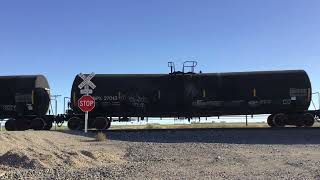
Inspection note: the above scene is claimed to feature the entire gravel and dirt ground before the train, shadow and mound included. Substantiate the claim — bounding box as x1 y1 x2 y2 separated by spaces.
0 129 320 179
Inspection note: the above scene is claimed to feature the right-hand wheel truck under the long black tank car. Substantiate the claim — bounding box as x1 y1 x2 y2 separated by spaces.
267 110 320 127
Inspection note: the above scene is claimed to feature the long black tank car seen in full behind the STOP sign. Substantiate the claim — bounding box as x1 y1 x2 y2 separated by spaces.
68 62 319 130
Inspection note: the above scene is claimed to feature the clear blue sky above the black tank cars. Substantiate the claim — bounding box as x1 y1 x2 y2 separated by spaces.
0 0 320 112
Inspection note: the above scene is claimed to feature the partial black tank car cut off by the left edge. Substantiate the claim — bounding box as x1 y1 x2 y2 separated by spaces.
0 75 54 131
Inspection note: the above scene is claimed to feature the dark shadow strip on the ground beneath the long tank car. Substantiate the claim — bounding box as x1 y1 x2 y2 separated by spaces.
64 128 320 145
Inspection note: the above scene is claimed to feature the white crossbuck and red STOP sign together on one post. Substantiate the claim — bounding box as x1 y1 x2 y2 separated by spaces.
78 73 96 133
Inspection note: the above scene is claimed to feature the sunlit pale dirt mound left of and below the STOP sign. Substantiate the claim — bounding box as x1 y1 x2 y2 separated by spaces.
0 131 123 177
